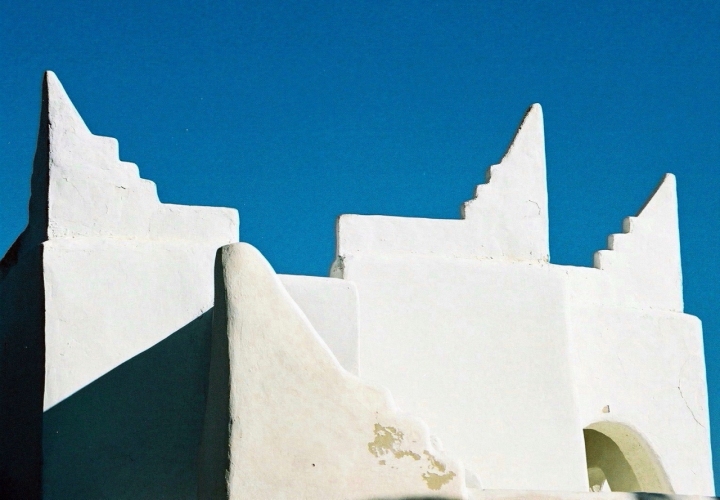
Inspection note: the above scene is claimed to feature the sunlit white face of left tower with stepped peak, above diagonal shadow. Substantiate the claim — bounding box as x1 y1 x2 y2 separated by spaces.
13 72 239 409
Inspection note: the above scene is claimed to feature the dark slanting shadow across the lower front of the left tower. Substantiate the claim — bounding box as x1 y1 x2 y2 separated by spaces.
43 309 212 500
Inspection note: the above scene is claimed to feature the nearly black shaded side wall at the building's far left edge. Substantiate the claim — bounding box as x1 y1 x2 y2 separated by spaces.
0 246 45 500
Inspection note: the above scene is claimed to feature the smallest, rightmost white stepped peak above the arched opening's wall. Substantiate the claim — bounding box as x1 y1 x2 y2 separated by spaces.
595 174 683 312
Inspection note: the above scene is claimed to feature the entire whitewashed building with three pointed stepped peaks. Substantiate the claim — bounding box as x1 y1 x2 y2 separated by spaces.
0 72 714 500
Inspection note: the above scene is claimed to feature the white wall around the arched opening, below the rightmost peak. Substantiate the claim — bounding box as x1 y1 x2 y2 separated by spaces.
568 304 714 496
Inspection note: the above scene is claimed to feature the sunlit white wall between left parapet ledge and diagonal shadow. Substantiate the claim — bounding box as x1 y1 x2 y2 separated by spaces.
43 238 222 409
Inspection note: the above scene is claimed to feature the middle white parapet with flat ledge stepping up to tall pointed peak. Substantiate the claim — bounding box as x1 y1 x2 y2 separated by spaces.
335 104 550 269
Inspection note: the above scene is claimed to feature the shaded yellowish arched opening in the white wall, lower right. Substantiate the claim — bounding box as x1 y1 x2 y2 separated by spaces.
583 422 673 493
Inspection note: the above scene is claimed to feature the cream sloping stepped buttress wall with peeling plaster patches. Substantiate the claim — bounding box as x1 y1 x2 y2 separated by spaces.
200 243 467 499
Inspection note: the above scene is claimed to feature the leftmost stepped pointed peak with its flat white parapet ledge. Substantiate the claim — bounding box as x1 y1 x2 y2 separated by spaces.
3 71 238 267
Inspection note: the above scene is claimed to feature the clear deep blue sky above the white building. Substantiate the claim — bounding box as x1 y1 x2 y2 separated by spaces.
0 0 720 488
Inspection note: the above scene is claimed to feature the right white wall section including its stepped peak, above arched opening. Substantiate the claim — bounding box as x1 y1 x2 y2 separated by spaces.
564 174 715 495
